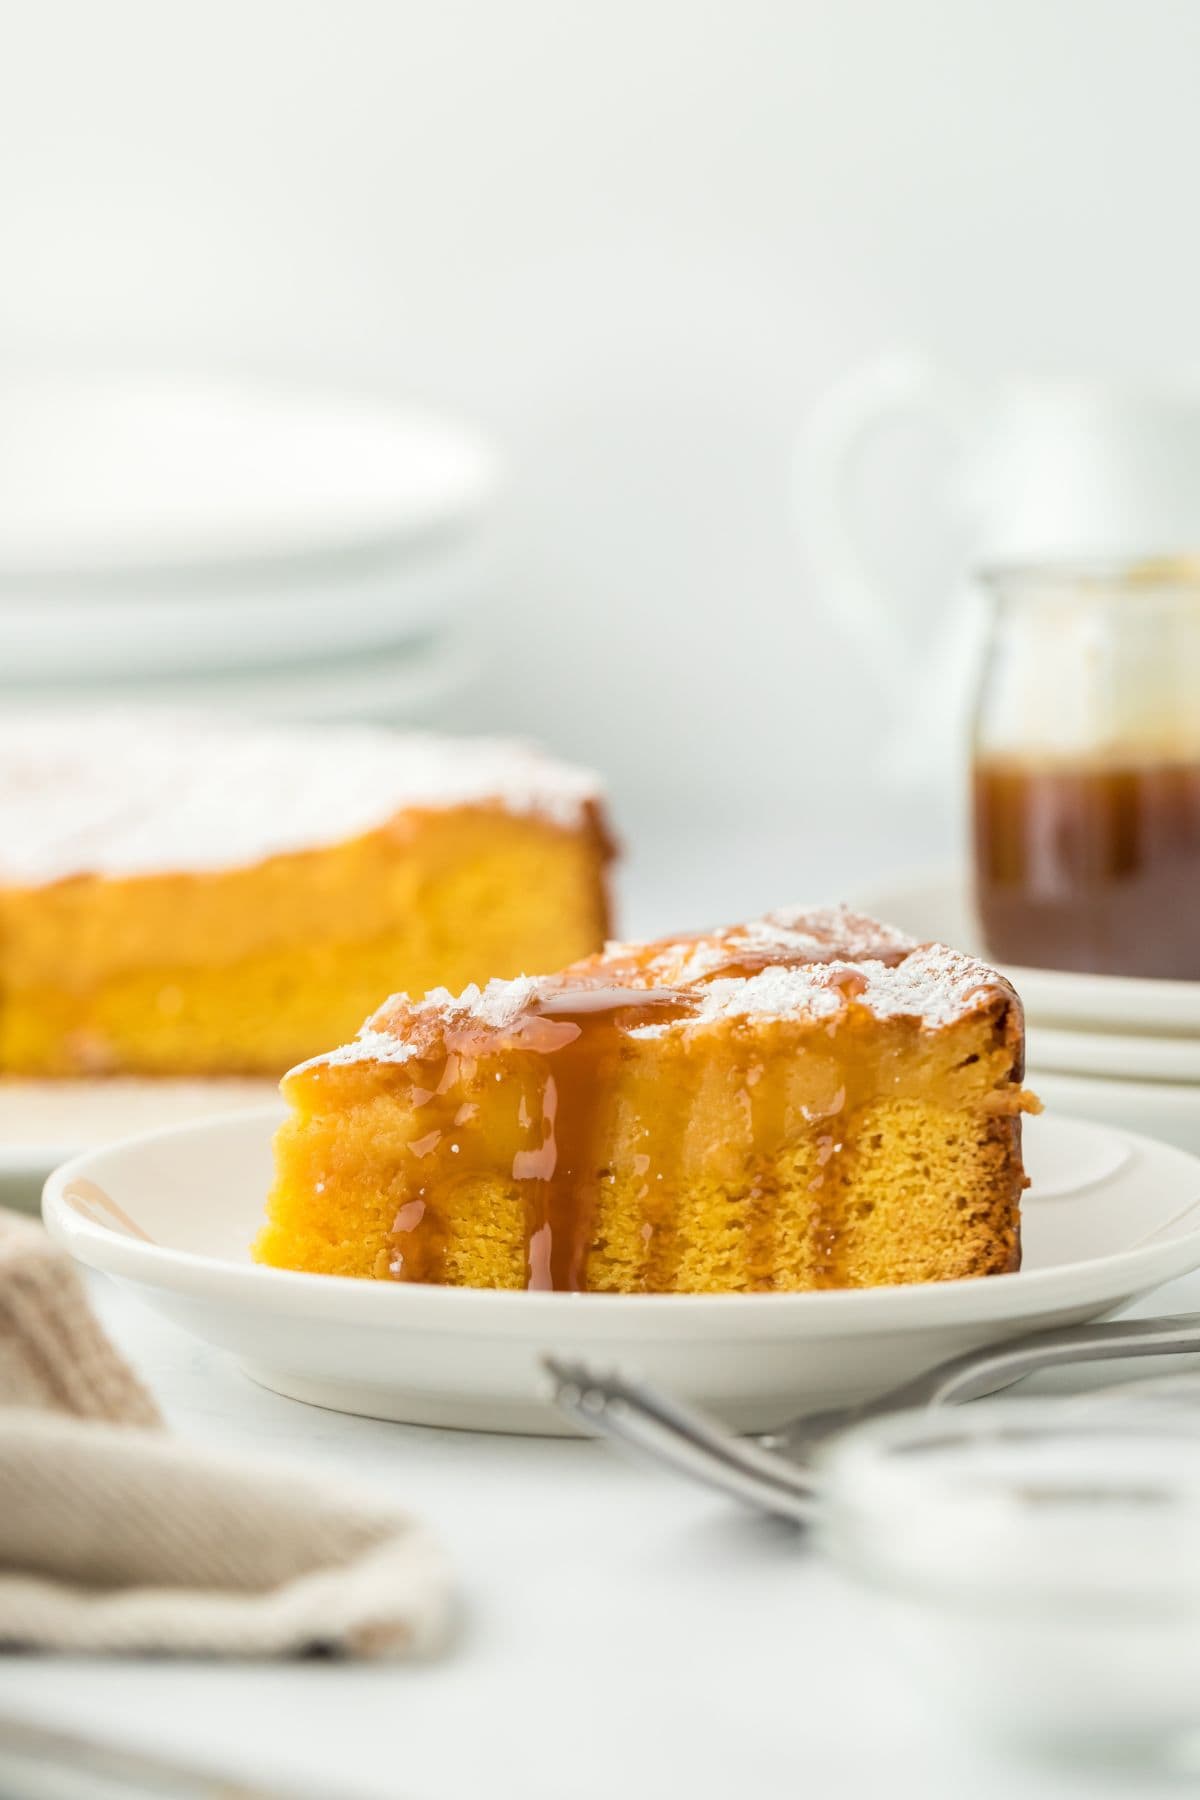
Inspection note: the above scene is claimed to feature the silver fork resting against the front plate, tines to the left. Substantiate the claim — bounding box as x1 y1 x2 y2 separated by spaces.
542 1312 1200 1525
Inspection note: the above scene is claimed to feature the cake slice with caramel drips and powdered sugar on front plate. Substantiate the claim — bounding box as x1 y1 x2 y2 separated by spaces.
255 909 1036 1292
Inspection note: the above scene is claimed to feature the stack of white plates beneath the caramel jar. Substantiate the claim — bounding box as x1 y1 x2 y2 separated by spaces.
862 871 1200 1152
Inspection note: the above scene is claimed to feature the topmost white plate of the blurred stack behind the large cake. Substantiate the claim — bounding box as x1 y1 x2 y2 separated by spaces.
0 367 497 576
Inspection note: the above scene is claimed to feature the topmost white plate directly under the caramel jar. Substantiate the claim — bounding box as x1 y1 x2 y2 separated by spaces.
855 869 1200 1037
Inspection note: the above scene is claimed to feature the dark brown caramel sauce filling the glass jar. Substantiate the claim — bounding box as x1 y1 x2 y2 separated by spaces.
973 759 1200 981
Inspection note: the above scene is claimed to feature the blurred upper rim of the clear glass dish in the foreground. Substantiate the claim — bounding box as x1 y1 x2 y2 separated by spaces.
819 1395 1200 1616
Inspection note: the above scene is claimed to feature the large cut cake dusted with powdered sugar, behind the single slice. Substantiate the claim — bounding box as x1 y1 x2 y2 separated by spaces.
0 716 610 1076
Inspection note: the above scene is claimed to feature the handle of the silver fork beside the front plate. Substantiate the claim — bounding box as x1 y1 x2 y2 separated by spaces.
887 1312 1200 1411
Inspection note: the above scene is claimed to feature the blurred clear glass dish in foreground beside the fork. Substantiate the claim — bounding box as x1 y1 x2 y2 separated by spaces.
819 1399 1200 1762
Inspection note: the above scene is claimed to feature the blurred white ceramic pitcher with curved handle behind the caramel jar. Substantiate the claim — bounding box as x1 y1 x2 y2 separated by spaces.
797 355 1200 785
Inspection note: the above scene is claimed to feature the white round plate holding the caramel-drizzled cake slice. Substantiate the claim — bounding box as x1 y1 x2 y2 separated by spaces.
43 1107 1200 1433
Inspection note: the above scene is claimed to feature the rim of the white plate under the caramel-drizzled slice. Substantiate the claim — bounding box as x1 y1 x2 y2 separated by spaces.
41 1103 1200 1337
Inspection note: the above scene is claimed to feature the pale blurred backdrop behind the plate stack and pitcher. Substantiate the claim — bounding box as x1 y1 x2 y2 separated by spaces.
0 0 1200 889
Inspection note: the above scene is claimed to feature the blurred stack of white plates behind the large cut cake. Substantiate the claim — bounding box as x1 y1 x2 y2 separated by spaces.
0 371 497 718
